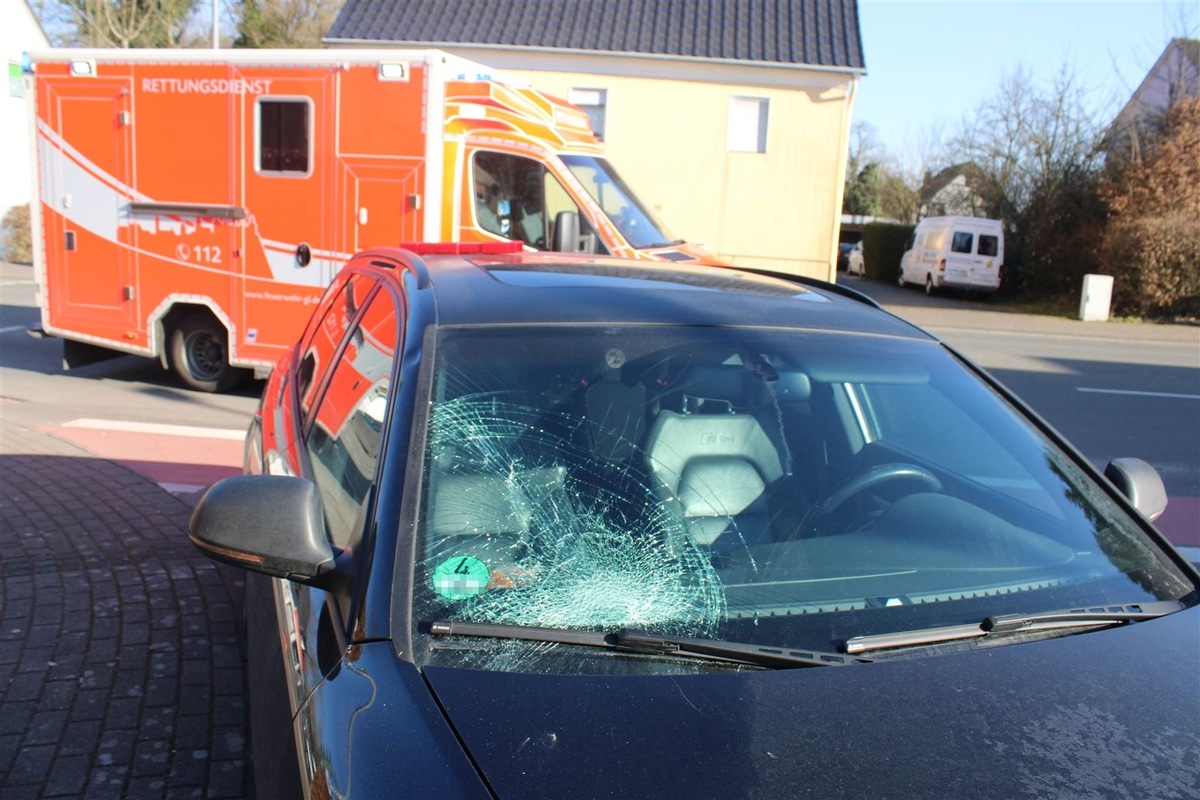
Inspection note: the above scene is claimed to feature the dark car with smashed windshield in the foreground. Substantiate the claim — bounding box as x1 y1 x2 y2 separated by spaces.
190 245 1200 799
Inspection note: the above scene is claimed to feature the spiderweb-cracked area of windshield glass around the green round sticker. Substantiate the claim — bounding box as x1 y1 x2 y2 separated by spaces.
417 392 725 636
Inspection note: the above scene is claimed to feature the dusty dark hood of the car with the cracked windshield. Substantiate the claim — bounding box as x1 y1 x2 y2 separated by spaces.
425 608 1200 800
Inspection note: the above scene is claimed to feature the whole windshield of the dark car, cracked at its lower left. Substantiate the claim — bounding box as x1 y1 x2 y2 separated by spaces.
413 326 1194 672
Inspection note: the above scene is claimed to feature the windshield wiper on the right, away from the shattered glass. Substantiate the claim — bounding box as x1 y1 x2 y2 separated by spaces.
846 600 1184 654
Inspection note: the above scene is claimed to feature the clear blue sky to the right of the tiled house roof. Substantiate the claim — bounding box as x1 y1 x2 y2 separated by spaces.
854 0 1200 164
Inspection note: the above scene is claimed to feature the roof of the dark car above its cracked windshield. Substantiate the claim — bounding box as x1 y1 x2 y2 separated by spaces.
359 248 932 339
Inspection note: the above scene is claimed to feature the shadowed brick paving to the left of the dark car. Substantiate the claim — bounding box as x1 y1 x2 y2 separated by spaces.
0 419 251 799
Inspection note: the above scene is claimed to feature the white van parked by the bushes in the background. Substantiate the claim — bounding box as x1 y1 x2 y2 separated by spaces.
900 217 1004 294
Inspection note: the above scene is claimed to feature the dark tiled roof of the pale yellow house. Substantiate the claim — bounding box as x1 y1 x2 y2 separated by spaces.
325 0 865 72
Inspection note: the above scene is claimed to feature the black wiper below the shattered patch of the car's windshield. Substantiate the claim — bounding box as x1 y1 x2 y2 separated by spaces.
430 620 870 669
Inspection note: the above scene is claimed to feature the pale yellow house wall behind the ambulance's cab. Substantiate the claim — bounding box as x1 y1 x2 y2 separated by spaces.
505 67 854 279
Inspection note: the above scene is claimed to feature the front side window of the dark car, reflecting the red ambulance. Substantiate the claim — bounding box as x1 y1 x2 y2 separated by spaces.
306 283 400 547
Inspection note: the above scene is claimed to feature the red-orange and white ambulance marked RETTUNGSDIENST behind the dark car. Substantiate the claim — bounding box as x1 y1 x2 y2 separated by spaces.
25 49 721 391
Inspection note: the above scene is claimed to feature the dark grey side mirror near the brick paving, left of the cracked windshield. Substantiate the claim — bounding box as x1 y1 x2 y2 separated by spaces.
188 475 348 588
